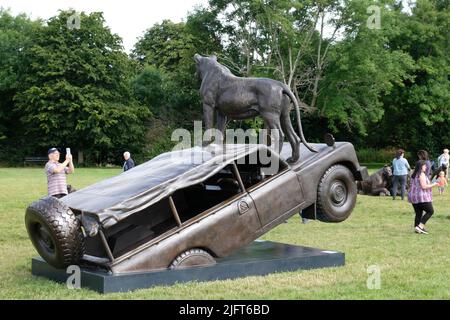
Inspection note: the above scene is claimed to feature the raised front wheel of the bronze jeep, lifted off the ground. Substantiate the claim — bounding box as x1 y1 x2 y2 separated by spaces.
317 165 357 222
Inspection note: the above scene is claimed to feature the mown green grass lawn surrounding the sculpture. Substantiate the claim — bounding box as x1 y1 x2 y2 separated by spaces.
0 168 450 299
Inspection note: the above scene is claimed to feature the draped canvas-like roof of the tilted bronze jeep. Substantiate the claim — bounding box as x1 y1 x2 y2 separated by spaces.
61 144 278 227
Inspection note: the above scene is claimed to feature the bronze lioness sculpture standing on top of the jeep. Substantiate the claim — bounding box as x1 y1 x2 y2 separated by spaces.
194 54 317 163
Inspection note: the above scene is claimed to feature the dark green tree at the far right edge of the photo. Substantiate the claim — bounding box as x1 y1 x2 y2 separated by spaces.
371 0 450 156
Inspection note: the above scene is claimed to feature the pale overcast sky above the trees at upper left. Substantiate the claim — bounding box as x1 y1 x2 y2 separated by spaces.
0 0 207 52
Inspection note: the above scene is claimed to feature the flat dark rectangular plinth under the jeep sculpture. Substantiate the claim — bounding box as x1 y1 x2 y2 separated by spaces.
31 240 345 298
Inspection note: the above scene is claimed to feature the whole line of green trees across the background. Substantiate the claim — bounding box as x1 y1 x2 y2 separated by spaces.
0 0 450 164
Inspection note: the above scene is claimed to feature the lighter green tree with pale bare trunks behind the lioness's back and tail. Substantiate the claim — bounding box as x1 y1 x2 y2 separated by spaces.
202 0 412 138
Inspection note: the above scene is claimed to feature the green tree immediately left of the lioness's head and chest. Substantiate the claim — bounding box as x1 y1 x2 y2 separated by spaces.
132 15 220 128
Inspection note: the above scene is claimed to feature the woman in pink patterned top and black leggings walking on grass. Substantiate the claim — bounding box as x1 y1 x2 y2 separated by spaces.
408 160 437 234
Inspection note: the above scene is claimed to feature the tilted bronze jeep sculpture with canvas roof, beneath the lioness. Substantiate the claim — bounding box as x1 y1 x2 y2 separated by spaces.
25 142 368 273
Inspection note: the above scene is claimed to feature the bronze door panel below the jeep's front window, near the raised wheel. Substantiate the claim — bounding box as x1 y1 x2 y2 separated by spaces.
247 169 304 228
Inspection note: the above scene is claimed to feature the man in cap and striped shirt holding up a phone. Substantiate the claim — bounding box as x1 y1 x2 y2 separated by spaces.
45 148 75 198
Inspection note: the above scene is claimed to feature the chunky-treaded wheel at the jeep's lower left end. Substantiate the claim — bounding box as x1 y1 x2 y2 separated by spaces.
25 197 84 268
